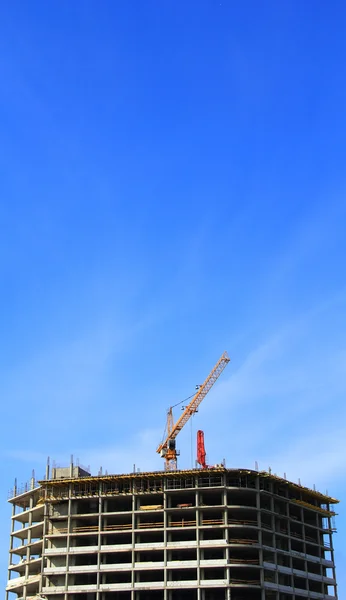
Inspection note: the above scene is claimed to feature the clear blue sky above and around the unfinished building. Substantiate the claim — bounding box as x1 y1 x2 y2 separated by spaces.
0 0 346 598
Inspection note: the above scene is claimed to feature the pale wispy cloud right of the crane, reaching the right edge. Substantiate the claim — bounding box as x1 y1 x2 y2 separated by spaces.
184 291 346 492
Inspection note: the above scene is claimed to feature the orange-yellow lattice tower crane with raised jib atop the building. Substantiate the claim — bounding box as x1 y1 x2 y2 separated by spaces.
156 352 230 471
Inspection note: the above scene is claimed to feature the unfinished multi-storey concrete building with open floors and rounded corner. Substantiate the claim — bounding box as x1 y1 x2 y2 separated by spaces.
7 466 337 600
